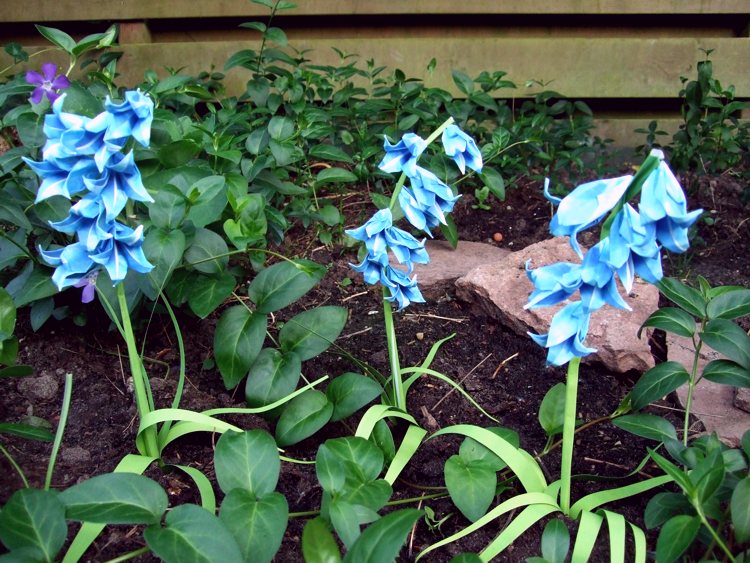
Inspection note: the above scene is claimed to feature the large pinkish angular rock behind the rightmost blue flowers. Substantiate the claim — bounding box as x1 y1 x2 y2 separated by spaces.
456 237 659 373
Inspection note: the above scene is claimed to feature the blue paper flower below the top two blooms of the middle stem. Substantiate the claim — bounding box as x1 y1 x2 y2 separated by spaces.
398 166 461 236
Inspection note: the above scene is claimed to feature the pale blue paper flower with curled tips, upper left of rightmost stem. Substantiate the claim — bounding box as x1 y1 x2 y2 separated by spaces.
544 176 633 257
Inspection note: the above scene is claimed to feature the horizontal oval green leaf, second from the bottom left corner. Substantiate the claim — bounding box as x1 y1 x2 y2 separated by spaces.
59 473 167 524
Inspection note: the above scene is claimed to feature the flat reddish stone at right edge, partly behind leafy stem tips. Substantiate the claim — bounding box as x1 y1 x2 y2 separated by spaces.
667 333 750 448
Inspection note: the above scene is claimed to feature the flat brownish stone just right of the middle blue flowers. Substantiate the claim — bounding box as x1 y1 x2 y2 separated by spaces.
408 240 510 296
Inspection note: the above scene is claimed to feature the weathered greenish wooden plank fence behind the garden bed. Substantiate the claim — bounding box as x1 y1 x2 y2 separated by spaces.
0 0 750 144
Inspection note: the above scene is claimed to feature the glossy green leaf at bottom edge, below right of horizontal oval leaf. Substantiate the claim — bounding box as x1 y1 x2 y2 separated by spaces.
143 504 244 563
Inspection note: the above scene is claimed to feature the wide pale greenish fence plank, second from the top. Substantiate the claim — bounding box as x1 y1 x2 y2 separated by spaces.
5 37 750 98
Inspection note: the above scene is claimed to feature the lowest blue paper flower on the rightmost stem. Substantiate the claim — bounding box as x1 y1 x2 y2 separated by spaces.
528 301 596 366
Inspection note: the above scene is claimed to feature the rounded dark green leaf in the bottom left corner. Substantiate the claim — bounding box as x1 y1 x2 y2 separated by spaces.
0 489 68 561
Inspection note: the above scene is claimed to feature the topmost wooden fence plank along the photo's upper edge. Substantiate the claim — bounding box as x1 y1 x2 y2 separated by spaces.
0 0 750 22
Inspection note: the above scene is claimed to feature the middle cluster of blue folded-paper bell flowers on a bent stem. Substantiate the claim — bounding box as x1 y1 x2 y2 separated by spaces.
346 124 482 310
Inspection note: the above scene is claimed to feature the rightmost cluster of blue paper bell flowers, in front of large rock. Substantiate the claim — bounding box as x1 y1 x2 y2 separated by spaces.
525 150 703 366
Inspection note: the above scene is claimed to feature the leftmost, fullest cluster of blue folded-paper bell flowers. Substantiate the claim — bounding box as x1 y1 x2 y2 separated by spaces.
24 91 154 300
